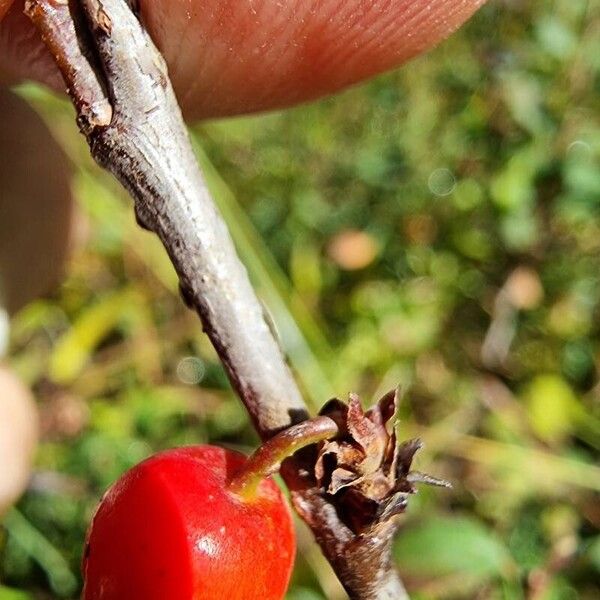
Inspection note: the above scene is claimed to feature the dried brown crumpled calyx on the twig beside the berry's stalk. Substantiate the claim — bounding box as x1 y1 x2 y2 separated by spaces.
315 390 451 534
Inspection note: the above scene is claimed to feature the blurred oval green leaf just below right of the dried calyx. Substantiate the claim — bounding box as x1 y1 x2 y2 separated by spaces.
395 517 511 582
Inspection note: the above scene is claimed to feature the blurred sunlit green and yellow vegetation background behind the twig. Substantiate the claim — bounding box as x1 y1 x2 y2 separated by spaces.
0 0 600 600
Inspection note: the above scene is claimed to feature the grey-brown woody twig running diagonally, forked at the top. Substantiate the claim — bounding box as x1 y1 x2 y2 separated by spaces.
26 0 406 600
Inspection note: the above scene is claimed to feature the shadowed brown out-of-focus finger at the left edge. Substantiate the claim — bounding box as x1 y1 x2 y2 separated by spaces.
0 88 77 313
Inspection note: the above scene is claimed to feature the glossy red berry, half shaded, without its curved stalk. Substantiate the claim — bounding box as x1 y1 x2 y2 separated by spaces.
82 446 295 600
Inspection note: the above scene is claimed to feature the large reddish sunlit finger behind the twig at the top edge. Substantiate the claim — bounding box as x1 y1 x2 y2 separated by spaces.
0 0 485 118
